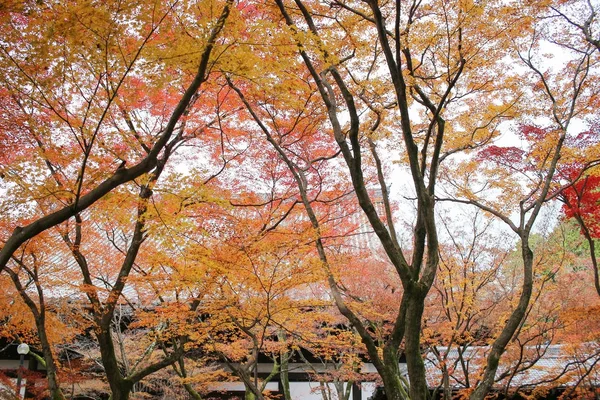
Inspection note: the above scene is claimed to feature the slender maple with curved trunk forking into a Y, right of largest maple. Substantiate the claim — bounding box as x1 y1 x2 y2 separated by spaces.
436 1 597 399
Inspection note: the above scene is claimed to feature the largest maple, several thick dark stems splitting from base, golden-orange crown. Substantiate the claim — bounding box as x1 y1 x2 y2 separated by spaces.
224 1 540 399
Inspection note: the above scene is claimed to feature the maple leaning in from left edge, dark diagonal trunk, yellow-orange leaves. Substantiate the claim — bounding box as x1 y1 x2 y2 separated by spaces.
0 0 226 265
